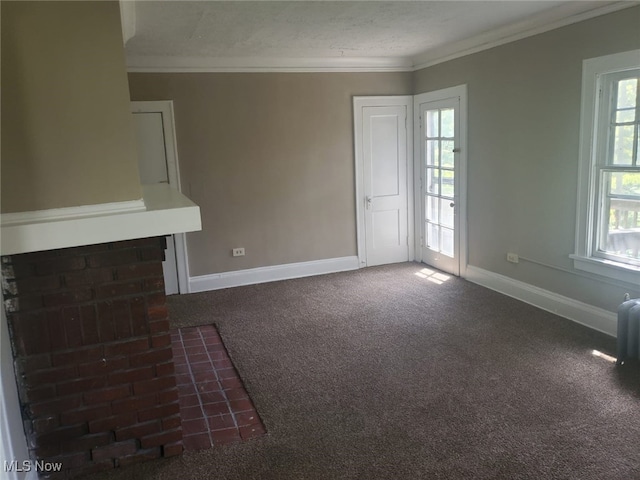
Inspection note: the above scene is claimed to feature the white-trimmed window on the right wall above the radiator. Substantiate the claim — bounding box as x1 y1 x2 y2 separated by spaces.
572 50 640 283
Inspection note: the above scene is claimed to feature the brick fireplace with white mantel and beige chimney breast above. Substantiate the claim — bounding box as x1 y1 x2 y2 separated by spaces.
0 1 202 480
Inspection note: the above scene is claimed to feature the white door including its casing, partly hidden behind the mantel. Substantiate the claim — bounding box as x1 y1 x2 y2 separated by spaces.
131 101 189 295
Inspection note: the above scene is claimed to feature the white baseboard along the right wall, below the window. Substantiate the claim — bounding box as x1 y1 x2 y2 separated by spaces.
465 265 618 337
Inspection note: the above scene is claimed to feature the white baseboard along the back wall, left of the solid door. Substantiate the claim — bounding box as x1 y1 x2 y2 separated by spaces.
189 256 360 293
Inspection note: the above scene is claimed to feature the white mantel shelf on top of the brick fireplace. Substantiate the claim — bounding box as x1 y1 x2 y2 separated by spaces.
0 184 202 255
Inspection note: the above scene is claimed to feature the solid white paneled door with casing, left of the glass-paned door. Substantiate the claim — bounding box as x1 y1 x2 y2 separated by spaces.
354 96 413 267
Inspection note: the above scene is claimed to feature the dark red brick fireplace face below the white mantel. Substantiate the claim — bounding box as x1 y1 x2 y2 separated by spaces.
2 237 182 478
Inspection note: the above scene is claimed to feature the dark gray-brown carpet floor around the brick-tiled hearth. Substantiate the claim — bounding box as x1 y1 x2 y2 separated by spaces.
92 263 640 480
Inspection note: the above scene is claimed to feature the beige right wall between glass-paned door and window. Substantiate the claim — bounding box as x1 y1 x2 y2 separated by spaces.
414 7 640 310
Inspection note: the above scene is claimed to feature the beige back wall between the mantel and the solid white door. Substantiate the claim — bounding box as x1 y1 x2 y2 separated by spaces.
129 73 412 276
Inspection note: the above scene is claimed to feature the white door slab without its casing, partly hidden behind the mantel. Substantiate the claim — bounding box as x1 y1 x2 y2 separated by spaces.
133 107 180 295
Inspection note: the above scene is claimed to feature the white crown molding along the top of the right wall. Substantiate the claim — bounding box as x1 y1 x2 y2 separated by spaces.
413 0 640 71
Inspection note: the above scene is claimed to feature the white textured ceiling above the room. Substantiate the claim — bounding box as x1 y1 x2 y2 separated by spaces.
126 0 632 69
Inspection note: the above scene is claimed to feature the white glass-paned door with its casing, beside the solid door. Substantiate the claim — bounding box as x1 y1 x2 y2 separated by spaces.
416 85 466 275
